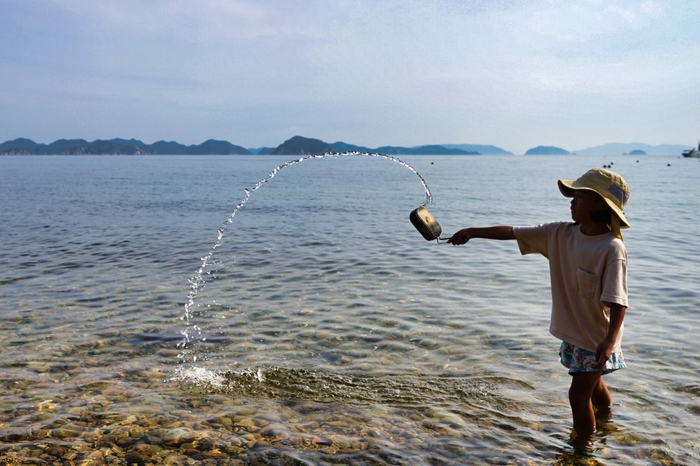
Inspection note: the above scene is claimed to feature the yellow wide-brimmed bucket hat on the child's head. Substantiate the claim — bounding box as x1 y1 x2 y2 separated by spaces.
557 168 630 238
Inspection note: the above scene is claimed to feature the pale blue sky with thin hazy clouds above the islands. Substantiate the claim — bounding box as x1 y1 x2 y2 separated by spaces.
0 0 700 154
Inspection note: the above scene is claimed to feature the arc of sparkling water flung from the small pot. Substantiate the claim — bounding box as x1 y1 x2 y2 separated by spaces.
178 152 433 361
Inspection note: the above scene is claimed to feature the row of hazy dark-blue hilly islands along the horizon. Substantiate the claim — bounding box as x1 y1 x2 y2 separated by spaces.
0 136 690 155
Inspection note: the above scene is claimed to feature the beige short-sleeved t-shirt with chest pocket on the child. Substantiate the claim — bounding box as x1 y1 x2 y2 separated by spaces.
513 222 627 351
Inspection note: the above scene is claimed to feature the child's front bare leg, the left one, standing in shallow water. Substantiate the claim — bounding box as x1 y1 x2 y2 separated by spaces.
569 371 610 439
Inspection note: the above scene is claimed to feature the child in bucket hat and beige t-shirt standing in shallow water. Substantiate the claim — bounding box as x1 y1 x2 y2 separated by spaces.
448 168 630 446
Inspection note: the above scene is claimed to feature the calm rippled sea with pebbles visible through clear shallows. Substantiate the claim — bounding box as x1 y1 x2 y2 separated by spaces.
0 154 700 466
